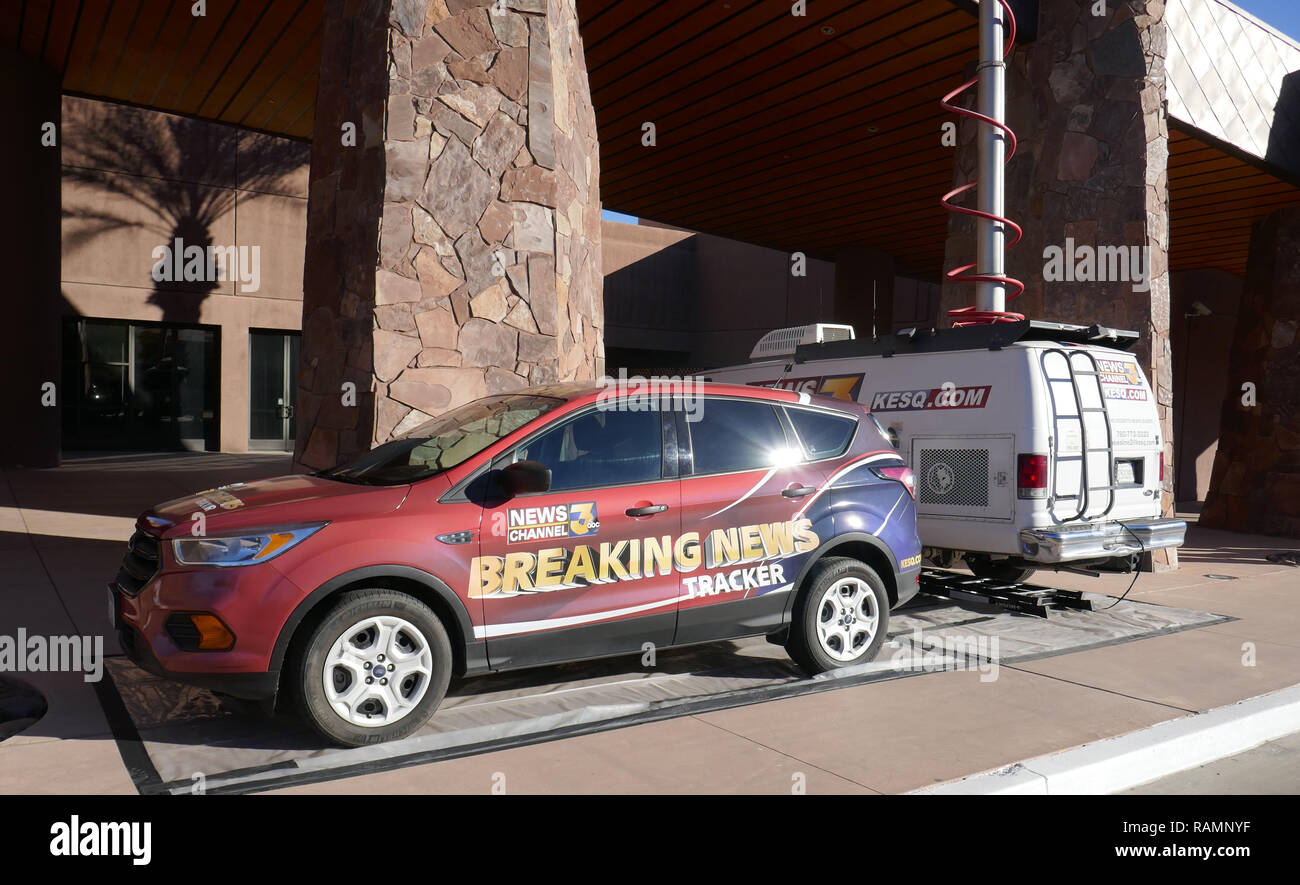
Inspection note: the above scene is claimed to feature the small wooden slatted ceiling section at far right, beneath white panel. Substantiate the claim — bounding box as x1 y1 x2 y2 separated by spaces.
1169 127 1300 277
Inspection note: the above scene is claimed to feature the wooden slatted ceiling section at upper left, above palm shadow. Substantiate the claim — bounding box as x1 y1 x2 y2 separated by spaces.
8 0 322 138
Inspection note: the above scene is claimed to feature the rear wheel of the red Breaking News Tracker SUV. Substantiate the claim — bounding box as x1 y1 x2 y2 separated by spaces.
785 556 889 674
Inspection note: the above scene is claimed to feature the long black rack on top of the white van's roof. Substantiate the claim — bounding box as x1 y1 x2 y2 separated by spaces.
794 320 1138 363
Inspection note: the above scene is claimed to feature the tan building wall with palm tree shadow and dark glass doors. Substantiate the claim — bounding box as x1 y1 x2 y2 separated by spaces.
59 96 309 452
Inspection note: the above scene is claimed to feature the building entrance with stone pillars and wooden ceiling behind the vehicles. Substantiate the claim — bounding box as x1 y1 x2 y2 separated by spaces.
0 0 1300 533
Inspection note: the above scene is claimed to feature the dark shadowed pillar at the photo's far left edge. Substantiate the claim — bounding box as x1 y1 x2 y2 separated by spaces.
0 48 60 467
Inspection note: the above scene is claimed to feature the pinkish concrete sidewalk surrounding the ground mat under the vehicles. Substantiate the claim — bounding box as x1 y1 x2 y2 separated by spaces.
0 455 1300 794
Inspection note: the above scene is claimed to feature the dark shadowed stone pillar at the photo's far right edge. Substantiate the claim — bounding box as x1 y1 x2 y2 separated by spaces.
1200 208 1300 538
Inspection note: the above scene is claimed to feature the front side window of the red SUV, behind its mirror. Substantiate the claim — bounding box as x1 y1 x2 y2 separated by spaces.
515 409 663 491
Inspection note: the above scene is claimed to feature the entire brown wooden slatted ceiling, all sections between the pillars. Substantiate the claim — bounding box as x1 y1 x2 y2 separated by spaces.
10 0 1300 279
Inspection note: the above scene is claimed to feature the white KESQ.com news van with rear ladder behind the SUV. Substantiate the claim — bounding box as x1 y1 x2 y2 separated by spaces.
705 320 1187 581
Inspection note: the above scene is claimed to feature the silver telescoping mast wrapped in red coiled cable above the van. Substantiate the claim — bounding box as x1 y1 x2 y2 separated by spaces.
940 0 1024 326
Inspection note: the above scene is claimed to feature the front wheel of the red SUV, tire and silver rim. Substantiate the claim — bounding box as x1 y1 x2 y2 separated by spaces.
294 590 451 747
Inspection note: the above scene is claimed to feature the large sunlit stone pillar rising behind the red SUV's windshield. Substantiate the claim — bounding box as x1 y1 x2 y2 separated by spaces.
295 0 605 468
